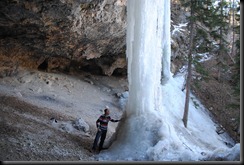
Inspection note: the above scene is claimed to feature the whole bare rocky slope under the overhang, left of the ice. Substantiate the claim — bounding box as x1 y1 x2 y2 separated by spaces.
0 69 128 161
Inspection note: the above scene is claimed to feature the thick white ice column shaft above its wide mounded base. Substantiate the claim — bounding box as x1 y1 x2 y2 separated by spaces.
126 0 165 116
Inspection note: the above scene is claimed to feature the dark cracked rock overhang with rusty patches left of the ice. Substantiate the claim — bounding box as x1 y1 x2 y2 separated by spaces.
0 0 126 76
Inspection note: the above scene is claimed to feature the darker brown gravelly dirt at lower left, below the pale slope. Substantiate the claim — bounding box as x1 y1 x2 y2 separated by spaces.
0 96 94 161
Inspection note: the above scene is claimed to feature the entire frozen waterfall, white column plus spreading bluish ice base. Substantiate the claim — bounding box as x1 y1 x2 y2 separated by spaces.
98 0 240 161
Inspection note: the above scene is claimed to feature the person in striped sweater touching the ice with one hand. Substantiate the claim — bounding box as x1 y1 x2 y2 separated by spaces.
92 108 120 151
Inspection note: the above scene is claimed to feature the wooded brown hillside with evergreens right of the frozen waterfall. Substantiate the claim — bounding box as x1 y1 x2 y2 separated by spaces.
180 0 241 141
